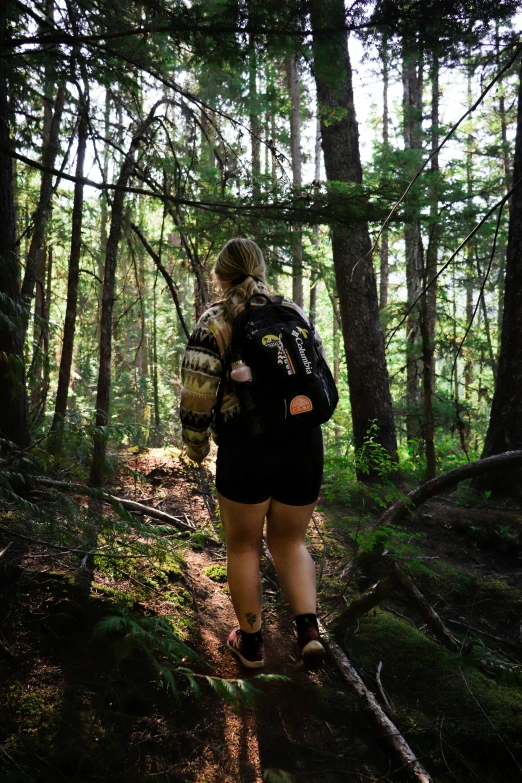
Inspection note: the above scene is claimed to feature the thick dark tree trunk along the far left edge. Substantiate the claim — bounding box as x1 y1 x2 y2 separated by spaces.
0 3 30 448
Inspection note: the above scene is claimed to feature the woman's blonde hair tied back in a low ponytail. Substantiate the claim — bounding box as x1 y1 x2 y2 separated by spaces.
214 238 270 323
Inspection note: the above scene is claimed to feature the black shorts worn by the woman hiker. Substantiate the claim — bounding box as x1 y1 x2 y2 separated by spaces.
216 427 324 506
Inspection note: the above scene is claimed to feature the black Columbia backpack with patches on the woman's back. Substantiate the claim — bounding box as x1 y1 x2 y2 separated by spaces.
218 294 339 435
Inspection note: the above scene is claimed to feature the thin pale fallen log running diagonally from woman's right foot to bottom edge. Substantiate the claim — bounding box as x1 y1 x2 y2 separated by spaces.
319 623 432 783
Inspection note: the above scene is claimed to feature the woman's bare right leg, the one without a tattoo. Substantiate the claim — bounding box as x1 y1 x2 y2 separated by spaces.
266 500 316 615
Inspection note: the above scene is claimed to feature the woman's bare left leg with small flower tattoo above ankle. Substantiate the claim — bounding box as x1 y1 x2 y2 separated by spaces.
218 493 270 633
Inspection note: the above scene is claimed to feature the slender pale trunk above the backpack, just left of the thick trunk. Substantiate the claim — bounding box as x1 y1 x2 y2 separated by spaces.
285 56 304 307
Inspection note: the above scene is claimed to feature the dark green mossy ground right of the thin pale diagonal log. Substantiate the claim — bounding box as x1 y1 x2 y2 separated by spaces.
347 610 522 783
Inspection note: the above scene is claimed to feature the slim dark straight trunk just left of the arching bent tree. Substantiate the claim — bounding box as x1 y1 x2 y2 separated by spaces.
51 107 88 440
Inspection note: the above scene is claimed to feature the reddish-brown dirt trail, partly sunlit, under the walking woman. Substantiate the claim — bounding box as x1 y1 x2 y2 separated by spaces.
118 451 378 783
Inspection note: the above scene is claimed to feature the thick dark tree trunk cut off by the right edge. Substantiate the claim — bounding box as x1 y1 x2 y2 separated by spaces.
483 61 522 493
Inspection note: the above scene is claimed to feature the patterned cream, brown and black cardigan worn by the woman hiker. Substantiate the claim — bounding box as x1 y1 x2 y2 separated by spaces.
180 299 324 462
